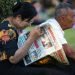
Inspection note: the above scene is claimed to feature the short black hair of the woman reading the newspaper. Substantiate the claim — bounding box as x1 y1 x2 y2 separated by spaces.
12 2 37 20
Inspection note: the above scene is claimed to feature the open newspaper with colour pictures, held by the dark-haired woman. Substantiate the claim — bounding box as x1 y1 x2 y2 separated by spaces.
18 23 69 66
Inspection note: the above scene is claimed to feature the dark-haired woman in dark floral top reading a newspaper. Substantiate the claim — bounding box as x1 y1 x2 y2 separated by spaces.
0 2 68 75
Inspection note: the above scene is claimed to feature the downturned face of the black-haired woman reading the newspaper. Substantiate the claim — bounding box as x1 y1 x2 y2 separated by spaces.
13 16 31 29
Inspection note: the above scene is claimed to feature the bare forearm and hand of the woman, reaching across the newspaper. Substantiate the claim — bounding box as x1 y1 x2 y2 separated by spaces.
9 27 43 64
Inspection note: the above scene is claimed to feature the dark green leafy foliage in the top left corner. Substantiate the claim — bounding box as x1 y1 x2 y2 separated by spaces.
0 0 23 17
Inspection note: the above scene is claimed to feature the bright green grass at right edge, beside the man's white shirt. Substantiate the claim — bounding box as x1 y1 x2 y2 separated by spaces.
65 29 75 48
